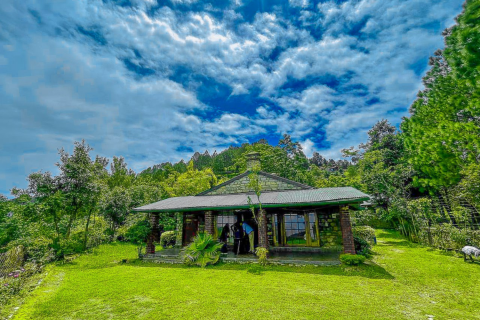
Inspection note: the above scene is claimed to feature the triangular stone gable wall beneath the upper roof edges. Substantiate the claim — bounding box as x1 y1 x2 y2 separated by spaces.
208 174 303 195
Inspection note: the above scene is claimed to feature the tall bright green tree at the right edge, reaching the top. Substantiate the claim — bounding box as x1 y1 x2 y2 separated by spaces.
402 0 480 192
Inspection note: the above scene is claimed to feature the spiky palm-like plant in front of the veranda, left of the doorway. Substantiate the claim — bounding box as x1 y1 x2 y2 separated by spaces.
182 233 223 268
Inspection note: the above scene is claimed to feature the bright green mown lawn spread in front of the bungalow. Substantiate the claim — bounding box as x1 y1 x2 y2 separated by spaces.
14 231 480 319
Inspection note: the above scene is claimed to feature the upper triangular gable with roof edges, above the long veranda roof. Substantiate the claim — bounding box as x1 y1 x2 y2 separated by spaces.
197 170 313 196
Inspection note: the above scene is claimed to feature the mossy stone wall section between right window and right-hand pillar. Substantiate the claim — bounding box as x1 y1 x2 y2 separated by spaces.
318 207 342 247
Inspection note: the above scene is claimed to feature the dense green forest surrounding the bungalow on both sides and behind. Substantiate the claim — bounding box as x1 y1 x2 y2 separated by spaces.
0 1 480 263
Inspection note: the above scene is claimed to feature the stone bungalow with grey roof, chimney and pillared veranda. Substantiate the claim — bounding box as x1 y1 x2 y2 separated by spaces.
134 153 369 255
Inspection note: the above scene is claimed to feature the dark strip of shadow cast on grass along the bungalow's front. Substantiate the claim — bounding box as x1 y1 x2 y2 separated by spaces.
123 259 394 279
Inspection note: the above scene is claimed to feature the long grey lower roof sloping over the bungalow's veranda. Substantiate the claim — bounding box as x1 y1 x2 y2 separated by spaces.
133 187 370 212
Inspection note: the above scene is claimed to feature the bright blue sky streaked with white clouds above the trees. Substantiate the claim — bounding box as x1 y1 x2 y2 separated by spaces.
0 0 461 194
